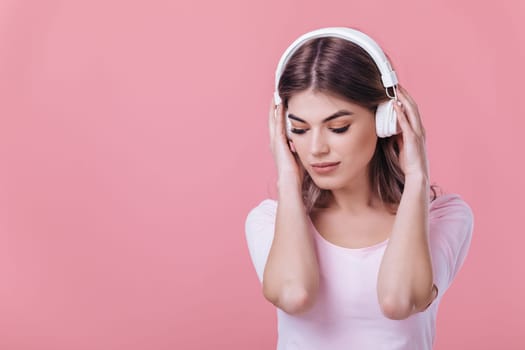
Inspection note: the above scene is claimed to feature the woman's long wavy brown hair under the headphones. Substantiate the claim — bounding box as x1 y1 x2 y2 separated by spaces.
278 37 437 214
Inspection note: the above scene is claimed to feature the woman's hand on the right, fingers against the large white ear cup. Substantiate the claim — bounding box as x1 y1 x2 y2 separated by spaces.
394 85 429 180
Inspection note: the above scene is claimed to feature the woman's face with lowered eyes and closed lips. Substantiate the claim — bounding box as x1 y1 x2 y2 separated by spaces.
287 90 377 190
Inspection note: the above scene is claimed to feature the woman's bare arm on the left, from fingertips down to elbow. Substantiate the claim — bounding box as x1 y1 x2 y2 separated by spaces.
263 102 319 314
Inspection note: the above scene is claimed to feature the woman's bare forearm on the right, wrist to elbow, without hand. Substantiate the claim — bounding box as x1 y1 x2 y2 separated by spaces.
377 176 433 318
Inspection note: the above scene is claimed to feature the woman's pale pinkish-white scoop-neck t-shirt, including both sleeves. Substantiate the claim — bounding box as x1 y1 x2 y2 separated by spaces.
245 194 473 350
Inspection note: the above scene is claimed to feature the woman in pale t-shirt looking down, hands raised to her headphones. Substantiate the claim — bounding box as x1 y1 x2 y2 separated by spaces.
246 28 473 350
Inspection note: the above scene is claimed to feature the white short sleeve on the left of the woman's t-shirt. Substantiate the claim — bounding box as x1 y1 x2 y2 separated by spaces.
245 199 277 283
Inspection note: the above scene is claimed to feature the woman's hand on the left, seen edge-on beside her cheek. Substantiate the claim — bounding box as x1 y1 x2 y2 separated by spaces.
269 98 305 188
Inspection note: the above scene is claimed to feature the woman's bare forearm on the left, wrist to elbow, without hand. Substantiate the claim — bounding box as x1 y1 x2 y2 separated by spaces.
263 179 319 313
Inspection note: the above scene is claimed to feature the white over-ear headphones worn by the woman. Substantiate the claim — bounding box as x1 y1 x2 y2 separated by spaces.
273 27 401 137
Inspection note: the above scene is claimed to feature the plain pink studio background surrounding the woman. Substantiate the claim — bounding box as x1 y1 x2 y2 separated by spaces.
0 0 525 350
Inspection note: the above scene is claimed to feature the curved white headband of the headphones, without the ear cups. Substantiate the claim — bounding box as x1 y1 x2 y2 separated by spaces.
274 27 397 105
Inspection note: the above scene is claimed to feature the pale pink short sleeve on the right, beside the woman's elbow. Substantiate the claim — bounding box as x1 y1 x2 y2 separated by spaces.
429 194 474 296
